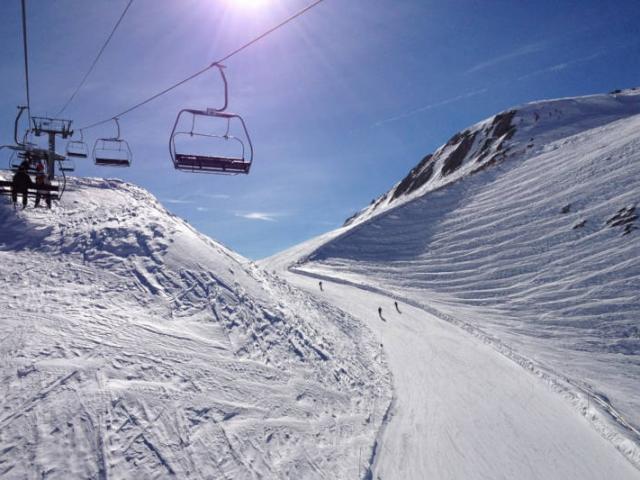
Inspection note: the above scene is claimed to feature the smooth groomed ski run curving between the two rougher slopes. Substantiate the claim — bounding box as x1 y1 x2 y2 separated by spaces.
286 272 640 480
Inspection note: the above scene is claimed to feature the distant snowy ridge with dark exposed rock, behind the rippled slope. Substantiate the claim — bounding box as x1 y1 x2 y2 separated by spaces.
345 88 640 226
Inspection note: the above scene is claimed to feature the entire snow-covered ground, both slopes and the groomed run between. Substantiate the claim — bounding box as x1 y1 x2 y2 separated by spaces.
0 91 640 480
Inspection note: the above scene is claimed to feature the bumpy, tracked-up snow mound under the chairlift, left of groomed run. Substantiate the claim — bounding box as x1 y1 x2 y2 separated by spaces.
0 180 391 479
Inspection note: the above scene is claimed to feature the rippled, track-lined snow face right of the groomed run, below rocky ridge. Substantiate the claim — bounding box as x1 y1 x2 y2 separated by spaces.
304 112 640 436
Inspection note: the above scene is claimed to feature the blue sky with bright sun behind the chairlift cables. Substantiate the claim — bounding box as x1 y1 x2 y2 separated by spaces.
0 0 640 258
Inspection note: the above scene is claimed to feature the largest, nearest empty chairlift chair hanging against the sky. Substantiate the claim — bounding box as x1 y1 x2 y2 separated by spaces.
169 64 253 175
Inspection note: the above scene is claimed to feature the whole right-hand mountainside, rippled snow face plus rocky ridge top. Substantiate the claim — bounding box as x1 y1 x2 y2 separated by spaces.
262 90 640 470
